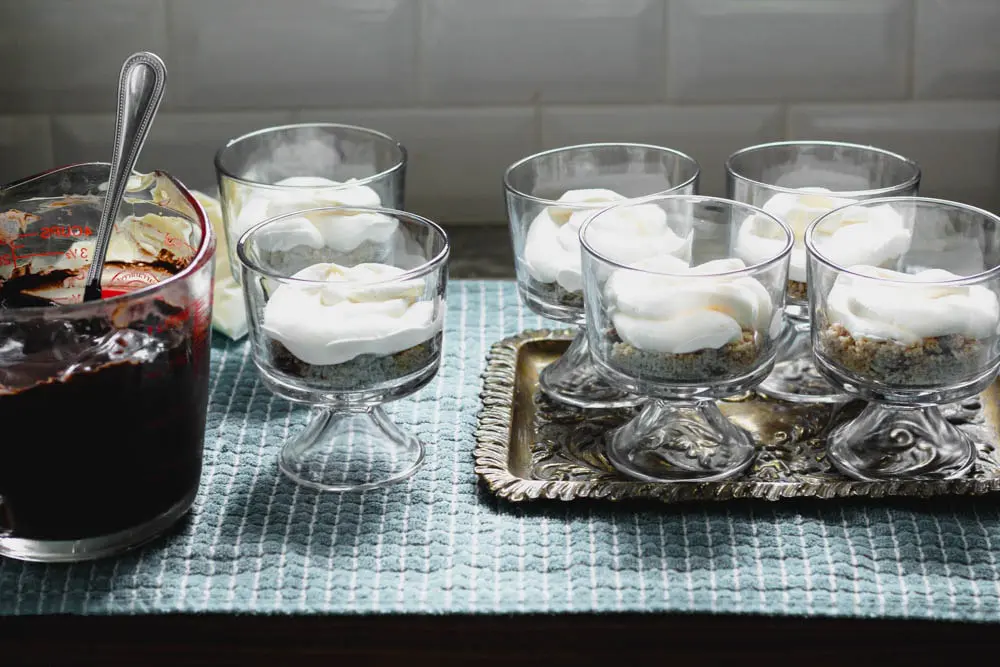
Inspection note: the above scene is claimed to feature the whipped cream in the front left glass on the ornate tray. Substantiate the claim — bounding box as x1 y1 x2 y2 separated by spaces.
604 256 781 354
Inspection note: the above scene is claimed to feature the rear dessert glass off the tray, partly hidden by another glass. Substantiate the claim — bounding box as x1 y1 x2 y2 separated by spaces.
215 123 406 280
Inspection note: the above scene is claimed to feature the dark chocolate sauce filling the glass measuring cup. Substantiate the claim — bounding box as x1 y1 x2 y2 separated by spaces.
0 298 210 540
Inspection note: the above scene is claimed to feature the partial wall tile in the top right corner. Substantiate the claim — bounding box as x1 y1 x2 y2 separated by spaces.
914 0 1000 98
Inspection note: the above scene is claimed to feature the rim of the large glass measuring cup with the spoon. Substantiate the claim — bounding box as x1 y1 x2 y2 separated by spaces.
0 162 215 321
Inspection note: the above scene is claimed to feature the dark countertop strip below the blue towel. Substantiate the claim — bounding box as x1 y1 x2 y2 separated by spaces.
0 615 1000 667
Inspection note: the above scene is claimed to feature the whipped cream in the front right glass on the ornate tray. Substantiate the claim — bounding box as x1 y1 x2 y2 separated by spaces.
826 265 1000 345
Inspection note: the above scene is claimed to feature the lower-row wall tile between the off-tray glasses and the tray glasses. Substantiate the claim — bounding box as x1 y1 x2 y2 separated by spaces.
297 107 539 222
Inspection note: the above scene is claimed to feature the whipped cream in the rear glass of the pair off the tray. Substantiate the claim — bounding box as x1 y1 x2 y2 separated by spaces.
230 176 399 253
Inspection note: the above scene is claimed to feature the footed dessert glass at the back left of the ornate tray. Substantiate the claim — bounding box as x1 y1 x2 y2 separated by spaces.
504 144 699 408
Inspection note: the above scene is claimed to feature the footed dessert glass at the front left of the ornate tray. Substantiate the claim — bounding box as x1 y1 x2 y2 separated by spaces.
580 195 792 482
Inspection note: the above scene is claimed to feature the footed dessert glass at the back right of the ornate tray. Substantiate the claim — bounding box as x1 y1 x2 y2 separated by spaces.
726 141 920 403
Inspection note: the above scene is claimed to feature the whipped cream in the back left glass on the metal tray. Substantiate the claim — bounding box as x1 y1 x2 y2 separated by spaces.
524 189 690 292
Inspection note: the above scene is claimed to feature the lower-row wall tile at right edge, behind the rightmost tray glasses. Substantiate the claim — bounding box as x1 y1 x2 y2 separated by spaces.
789 102 1000 210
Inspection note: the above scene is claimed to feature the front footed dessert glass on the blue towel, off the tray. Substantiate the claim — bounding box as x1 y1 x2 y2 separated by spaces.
237 207 449 491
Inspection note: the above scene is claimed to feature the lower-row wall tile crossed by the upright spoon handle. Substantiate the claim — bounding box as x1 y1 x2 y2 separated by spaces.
53 111 293 191
